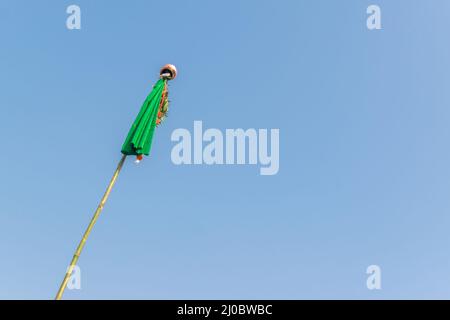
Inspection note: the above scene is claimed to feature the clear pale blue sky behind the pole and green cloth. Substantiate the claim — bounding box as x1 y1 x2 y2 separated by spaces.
0 0 450 299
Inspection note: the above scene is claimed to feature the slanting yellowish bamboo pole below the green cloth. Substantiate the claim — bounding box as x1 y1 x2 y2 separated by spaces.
55 155 127 300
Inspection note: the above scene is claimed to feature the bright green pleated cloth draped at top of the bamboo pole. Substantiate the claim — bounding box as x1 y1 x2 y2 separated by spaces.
122 79 166 156
